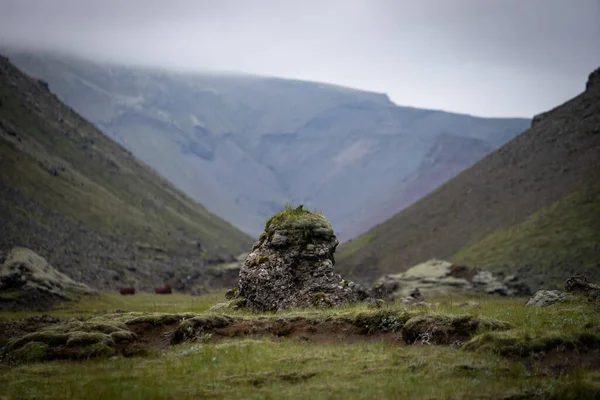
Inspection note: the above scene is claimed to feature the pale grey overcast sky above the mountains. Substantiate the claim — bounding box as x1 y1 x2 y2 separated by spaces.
0 0 600 117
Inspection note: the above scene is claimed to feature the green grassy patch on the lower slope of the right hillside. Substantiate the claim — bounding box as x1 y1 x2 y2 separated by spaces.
451 187 600 286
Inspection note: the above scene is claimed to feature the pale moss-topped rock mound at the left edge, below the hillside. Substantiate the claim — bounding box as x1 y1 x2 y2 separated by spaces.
0 247 93 310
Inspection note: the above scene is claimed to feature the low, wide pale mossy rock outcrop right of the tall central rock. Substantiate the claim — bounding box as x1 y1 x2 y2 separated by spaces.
372 259 531 303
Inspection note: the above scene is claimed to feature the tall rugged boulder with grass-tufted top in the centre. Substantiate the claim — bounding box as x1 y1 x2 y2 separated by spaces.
235 206 367 311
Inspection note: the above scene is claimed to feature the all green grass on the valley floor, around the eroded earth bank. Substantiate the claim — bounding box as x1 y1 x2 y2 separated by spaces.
0 292 600 400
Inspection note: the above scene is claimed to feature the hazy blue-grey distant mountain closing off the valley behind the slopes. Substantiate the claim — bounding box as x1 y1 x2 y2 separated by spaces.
4 51 530 241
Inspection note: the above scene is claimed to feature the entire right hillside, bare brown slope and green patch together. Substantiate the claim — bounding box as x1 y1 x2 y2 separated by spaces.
338 69 600 287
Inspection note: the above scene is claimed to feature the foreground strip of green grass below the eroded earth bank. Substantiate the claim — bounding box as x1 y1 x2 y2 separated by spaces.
0 340 598 399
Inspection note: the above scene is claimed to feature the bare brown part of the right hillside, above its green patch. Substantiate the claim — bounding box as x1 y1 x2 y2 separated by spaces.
338 70 600 286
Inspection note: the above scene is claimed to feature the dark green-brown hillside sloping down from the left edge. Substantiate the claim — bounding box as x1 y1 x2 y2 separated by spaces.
0 57 252 288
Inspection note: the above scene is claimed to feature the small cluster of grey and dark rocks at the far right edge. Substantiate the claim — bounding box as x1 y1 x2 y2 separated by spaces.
525 275 600 307
